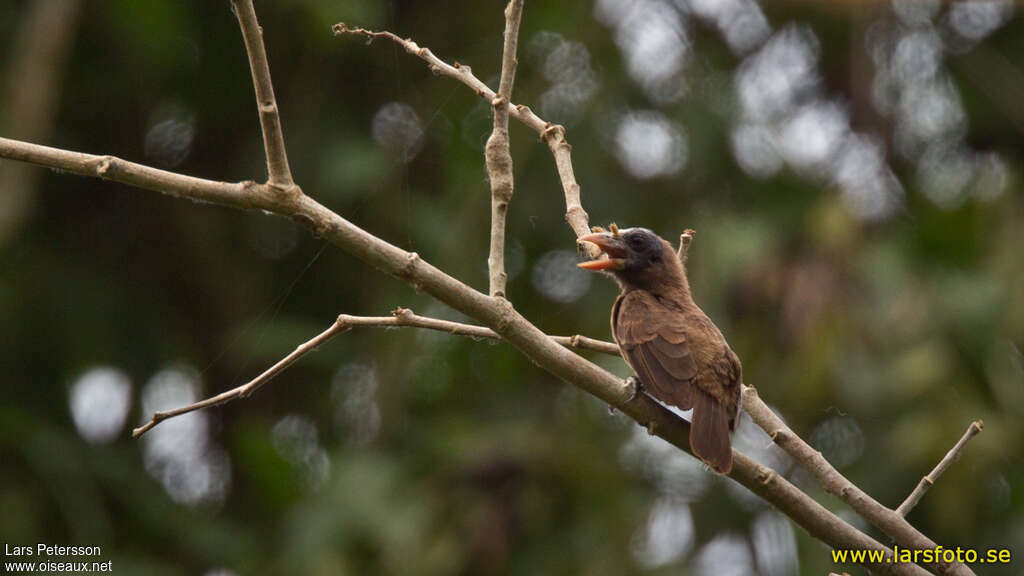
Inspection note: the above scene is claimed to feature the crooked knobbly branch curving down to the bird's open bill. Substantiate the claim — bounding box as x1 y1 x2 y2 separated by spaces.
332 23 600 258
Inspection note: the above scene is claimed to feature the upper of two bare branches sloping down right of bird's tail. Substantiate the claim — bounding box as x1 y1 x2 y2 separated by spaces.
742 385 974 575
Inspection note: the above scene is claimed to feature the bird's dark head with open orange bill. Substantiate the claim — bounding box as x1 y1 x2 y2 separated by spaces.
578 227 688 292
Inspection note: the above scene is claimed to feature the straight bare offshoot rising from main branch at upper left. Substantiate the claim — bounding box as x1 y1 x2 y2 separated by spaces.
231 0 295 190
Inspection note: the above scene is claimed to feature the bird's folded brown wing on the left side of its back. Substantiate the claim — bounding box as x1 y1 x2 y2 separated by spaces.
611 290 697 410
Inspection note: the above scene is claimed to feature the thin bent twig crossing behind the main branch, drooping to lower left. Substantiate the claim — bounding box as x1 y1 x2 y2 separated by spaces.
131 307 618 438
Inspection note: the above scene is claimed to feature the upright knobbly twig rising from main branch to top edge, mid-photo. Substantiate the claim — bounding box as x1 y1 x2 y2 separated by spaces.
483 0 523 297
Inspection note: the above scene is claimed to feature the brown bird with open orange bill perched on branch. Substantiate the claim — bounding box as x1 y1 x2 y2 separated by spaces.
579 224 742 474
